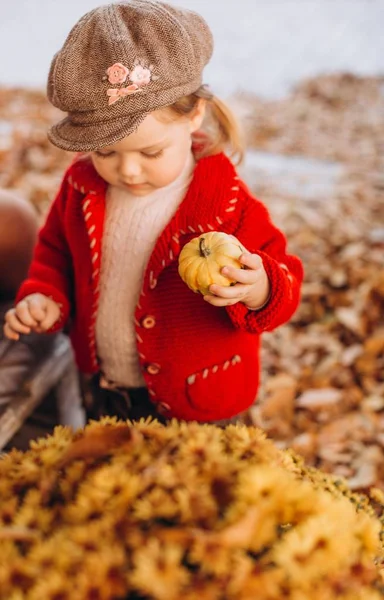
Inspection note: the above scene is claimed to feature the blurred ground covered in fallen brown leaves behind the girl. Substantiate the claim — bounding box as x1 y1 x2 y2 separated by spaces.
0 75 384 489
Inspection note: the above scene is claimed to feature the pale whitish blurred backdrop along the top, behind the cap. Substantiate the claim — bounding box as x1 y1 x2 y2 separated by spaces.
0 0 384 98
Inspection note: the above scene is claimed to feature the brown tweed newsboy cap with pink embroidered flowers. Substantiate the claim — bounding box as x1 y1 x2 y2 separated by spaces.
48 0 213 152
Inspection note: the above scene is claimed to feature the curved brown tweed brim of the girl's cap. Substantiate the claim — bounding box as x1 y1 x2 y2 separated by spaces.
48 112 148 152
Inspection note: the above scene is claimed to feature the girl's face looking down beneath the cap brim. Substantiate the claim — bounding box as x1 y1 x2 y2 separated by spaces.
91 102 205 196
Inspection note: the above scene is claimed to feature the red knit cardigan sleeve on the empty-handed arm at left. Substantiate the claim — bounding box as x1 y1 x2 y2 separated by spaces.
16 179 72 332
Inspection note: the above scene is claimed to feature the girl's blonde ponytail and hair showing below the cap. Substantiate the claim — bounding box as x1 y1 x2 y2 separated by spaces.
160 88 245 165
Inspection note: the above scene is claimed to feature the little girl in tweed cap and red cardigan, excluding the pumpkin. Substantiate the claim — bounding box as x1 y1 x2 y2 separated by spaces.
4 0 302 422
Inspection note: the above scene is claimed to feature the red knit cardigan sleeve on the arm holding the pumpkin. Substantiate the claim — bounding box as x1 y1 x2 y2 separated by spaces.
227 190 303 334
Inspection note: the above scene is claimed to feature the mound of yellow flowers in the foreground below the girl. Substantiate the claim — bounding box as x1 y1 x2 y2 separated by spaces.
0 419 384 600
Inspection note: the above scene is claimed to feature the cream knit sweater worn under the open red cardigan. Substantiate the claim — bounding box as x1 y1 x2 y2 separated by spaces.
96 153 195 387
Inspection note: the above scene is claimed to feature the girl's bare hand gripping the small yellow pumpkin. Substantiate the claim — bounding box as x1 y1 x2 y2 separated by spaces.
204 253 270 310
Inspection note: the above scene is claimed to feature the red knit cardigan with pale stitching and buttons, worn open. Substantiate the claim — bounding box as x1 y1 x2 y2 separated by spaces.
17 154 303 421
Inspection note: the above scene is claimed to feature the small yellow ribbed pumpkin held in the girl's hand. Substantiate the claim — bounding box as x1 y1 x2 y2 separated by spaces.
179 231 244 295
